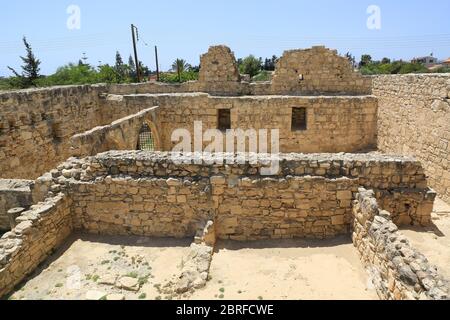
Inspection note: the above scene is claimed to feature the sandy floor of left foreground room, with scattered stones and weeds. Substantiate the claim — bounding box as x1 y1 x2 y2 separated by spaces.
10 235 191 300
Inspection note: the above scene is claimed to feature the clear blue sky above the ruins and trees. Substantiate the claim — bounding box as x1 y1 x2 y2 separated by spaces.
0 0 450 76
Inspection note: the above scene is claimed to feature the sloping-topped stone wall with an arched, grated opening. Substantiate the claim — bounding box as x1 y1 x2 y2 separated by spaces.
70 107 160 157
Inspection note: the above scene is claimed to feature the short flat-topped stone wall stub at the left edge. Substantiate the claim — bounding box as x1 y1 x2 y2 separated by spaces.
0 179 34 231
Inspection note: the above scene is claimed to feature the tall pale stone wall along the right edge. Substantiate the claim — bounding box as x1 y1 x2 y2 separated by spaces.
373 74 450 202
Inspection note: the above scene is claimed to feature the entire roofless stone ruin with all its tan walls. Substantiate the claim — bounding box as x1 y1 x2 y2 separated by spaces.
0 46 450 299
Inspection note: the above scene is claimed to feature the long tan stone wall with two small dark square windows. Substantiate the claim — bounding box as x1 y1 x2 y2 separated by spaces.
122 93 377 153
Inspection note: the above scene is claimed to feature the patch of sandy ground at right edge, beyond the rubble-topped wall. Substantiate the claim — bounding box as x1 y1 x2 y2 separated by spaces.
402 199 450 279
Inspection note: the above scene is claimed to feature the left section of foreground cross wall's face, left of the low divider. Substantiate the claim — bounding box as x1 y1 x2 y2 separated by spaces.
71 176 212 238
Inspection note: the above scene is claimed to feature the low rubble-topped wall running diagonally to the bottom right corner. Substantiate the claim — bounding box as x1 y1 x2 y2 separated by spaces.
353 188 450 300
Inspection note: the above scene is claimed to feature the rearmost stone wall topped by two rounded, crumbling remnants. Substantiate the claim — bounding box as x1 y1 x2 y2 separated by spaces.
104 46 372 96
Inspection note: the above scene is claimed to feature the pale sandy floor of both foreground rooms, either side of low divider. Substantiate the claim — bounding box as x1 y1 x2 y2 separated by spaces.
10 235 377 300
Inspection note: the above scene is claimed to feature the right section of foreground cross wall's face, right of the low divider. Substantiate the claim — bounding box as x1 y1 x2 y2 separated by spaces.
211 177 358 241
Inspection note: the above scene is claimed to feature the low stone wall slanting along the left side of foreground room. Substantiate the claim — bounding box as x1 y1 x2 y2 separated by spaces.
0 194 72 297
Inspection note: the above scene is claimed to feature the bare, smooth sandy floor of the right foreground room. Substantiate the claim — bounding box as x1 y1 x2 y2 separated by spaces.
191 237 378 300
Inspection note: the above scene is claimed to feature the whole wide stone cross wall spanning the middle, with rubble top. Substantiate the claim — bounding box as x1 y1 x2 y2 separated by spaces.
47 151 434 240
